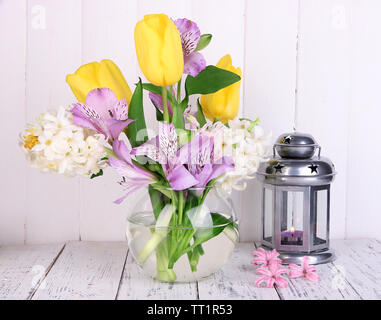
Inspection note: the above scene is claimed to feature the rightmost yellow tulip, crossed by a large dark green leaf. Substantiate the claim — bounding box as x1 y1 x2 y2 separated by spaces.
201 54 242 123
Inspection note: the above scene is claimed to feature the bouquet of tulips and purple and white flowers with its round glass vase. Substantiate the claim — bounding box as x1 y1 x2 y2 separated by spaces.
20 14 268 282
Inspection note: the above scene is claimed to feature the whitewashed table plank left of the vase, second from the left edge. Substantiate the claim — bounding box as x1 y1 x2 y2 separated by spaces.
33 242 127 300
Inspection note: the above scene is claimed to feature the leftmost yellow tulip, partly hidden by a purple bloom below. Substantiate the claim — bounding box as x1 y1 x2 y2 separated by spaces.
66 60 132 104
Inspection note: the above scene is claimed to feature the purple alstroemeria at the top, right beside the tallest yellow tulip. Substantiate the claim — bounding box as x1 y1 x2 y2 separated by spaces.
174 18 206 77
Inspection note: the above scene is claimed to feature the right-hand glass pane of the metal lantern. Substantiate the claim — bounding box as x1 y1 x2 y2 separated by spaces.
313 190 328 245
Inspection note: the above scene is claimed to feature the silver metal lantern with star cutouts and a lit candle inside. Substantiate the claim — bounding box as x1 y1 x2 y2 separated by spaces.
257 132 336 264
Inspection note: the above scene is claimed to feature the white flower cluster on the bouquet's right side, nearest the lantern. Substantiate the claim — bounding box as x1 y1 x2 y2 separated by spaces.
211 119 271 194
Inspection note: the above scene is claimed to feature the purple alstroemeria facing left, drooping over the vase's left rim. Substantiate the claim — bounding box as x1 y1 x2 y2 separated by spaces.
109 140 156 204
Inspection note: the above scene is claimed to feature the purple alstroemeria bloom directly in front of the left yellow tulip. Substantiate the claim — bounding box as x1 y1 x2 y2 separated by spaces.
71 88 134 139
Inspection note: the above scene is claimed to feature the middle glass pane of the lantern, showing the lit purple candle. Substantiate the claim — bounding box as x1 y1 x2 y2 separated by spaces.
281 191 304 246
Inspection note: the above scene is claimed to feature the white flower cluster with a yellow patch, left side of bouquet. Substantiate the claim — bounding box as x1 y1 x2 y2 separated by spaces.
20 107 106 177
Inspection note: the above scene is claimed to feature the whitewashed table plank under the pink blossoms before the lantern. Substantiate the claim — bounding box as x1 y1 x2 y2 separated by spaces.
256 243 360 300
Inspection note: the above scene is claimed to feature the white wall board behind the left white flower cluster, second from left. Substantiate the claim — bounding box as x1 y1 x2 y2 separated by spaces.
26 0 81 243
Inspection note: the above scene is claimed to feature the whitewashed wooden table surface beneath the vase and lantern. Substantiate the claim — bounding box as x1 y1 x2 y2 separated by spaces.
0 239 381 300
